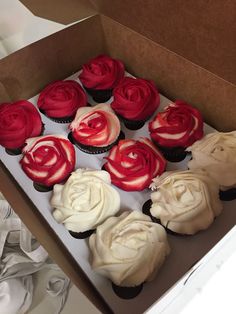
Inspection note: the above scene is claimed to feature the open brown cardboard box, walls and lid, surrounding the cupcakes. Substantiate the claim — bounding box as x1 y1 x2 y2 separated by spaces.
0 0 236 313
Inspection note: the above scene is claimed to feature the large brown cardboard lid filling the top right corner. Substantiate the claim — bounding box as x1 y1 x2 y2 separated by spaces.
91 0 236 84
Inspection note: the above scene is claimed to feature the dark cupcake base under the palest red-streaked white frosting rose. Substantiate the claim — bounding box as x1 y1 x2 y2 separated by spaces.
68 131 125 154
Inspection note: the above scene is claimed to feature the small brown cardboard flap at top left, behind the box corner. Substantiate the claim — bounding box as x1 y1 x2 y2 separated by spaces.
20 0 97 24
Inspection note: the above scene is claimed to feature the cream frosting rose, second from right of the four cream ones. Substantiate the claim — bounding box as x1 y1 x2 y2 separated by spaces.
150 169 222 234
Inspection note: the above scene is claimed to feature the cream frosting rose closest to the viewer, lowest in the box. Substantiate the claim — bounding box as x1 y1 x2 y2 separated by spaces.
89 211 170 287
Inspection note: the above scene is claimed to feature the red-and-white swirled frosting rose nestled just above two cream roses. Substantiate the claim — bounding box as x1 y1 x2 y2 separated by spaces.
104 138 166 191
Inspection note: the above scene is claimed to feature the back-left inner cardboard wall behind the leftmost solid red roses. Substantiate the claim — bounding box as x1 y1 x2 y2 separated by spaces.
0 15 105 102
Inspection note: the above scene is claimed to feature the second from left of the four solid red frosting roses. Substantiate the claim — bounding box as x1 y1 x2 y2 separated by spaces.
37 80 87 118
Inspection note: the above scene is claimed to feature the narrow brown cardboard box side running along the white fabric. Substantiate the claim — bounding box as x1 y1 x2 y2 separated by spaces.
0 161 113 314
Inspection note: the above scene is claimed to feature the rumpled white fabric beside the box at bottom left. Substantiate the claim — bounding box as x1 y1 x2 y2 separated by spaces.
0 197 70 314
